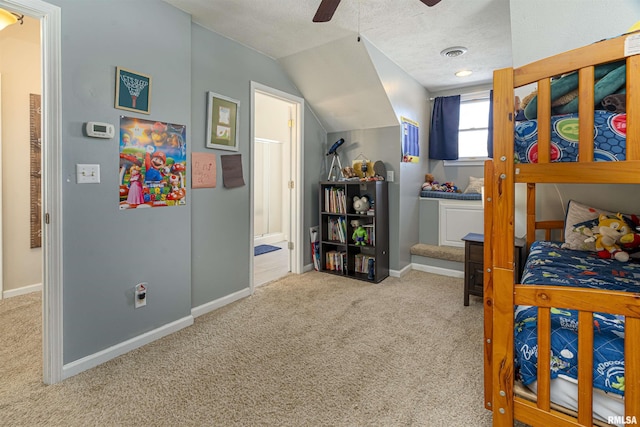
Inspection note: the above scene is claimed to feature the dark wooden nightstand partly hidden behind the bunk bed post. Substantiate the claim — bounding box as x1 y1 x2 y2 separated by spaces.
462 233 527 306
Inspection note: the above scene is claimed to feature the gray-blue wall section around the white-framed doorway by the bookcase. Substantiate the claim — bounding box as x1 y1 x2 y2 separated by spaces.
191 24 326 307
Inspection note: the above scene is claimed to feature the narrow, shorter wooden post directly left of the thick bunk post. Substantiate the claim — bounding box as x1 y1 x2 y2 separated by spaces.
482 160 494 410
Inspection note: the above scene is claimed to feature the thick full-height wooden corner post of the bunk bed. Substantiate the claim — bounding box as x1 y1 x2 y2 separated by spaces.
485 68 515 426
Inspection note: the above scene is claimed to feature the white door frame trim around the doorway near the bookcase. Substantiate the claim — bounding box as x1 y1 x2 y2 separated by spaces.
249 81 304 293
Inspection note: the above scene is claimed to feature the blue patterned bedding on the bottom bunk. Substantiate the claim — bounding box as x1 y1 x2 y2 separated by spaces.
515 242 640 395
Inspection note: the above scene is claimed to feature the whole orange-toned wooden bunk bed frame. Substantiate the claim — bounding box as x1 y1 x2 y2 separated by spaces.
484 32 640 426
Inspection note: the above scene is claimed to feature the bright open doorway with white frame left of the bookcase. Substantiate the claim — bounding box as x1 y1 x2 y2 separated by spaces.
250 82 303 290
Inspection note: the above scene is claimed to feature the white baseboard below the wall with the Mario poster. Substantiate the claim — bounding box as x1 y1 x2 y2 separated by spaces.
62 316 193 379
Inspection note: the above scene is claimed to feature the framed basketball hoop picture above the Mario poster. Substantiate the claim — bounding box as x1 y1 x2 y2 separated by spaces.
116 67 151 114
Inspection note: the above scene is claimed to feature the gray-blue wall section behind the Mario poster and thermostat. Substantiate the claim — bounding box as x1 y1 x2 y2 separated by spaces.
51 0 192 363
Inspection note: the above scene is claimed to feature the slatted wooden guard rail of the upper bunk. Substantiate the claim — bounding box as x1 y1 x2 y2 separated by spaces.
511 37 640 183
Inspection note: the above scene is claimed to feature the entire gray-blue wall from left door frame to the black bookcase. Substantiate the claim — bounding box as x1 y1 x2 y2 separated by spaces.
50 0 326 364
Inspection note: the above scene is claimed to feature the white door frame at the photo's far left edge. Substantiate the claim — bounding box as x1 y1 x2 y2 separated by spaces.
0 0 64 384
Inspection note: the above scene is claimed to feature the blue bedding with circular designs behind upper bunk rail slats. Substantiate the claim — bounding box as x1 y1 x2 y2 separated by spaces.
515 110 627 163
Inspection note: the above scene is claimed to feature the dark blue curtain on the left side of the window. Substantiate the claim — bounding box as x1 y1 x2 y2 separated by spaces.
429 95 460 160
